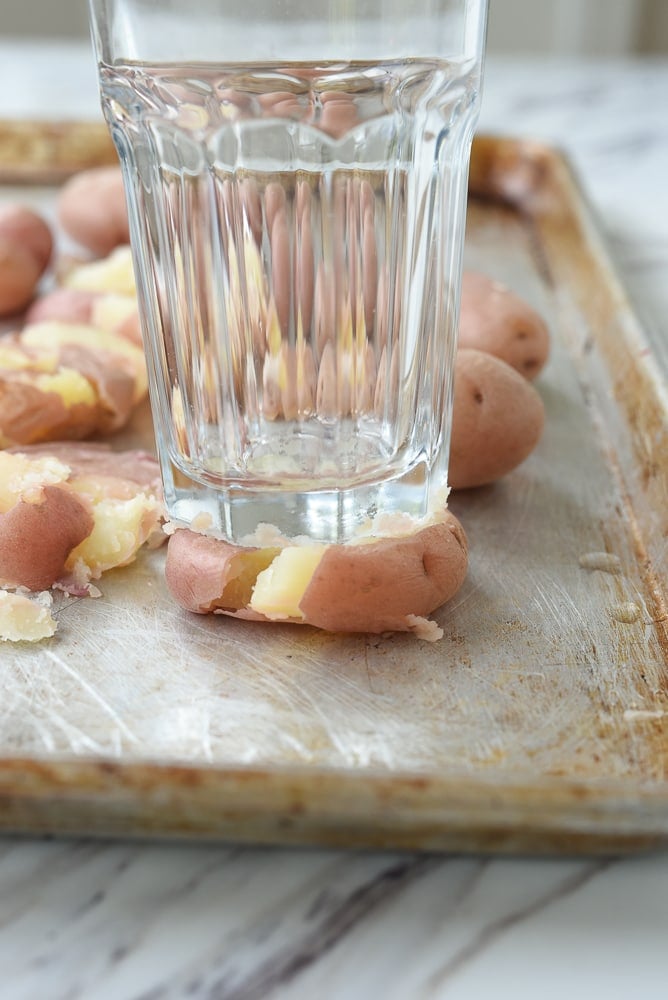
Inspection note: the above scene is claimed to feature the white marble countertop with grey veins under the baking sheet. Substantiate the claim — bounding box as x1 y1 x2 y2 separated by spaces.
0 40 668 1000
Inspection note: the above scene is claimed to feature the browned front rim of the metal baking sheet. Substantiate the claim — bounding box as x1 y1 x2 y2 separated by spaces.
0 760 668 853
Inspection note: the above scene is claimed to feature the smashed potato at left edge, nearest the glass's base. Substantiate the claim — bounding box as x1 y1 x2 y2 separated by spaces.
0 445 163 595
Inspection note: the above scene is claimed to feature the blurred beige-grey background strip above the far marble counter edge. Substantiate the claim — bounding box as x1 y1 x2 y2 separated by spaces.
0 0 668 56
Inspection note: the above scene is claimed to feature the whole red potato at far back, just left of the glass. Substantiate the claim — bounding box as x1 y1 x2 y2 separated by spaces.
57 167 130 257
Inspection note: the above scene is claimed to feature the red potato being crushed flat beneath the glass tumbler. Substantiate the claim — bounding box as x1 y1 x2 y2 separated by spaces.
166 511 468 638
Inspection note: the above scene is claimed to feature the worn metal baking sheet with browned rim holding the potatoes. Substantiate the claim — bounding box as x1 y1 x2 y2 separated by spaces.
0 123 668 853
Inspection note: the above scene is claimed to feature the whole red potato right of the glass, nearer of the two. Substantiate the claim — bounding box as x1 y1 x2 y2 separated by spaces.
448 350 545 489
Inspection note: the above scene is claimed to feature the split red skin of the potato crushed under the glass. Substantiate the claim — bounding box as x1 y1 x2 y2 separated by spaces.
165 511 468 633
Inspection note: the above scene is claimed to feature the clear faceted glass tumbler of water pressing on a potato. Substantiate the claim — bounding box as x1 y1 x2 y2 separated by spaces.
90 0 487 542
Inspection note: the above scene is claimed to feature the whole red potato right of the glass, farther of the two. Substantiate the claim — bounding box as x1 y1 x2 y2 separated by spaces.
459 271 550 380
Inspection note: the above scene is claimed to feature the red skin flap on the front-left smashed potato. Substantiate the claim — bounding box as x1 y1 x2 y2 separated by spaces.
0 486 93 590
